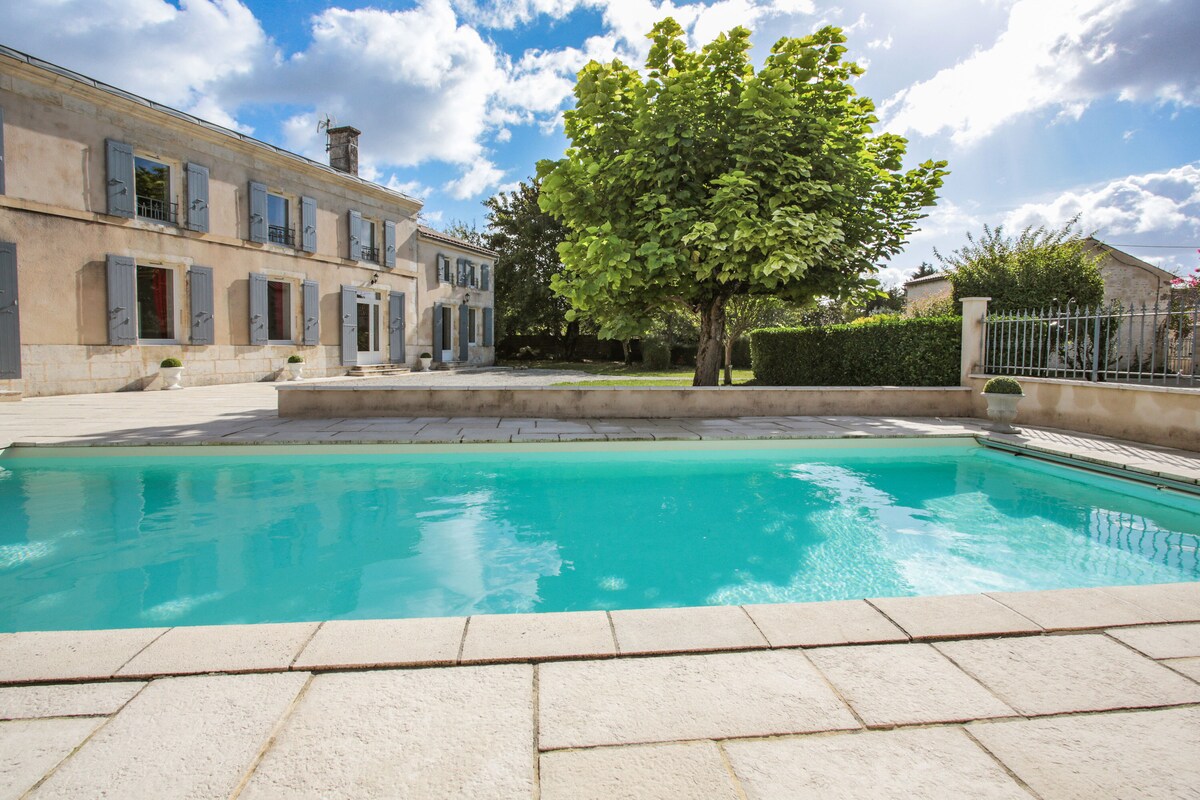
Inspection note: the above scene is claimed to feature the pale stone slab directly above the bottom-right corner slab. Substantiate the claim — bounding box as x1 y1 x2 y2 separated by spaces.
935 633 1200 716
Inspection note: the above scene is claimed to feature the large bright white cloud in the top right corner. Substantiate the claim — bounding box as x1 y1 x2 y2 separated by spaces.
881 0 1200 145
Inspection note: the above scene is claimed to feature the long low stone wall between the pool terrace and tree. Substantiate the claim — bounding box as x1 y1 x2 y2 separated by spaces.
278 383 971 419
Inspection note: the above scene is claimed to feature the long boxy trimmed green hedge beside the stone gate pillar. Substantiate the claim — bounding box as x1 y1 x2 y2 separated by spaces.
750 317 962 386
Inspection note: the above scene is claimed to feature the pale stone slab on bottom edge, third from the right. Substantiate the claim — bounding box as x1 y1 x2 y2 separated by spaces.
539 741 742 800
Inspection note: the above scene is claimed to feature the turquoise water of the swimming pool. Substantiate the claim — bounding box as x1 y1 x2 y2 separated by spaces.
0 443 1200 631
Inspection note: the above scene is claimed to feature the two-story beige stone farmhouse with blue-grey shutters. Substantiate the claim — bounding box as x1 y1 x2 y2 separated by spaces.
0 47 496 397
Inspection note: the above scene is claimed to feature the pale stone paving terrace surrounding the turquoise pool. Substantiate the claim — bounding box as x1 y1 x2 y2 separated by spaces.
0 384 1200 800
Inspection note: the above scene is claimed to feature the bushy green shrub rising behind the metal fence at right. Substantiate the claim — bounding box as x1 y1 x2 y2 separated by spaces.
934 225 1104 312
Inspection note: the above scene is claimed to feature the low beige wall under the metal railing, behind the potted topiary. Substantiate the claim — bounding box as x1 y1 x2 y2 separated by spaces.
967 374 1200 450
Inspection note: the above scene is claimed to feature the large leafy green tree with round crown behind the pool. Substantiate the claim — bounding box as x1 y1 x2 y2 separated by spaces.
538 19 946 385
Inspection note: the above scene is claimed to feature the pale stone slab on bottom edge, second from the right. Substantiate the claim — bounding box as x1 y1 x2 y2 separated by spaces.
725 728 1030 800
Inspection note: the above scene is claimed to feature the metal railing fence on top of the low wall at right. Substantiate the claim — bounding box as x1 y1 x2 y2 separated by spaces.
983 299 1200 387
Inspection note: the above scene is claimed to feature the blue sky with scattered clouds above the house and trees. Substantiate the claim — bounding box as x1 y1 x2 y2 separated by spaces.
0 0 1200 283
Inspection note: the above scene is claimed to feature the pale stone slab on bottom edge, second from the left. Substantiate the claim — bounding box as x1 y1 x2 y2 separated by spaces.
30 673 308 800
